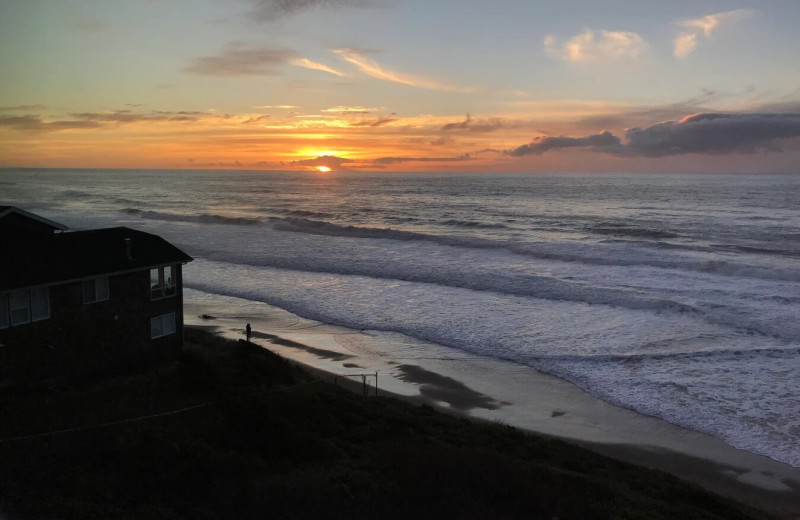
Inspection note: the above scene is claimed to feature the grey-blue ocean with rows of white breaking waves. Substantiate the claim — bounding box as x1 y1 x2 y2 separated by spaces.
0 169 800 467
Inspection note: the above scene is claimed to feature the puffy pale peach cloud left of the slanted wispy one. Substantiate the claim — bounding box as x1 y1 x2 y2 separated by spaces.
544 29 647 62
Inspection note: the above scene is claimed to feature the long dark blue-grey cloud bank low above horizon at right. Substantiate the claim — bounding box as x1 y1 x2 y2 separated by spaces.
504 113 800 157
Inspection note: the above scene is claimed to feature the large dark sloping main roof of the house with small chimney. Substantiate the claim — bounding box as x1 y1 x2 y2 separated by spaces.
0 227 192 290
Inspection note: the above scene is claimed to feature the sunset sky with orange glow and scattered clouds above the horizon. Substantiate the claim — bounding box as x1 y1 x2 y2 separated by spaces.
0 0 800 173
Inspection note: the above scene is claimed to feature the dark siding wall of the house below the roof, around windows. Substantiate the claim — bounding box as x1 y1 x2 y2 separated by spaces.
0 264 183 383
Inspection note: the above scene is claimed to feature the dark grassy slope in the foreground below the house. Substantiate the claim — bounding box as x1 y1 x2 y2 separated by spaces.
0 331 768 520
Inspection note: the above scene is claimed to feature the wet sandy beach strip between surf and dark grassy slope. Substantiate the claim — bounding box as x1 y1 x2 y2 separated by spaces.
185 290 800 515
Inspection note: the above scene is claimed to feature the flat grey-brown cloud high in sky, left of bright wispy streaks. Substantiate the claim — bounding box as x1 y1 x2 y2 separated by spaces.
184 42 294 77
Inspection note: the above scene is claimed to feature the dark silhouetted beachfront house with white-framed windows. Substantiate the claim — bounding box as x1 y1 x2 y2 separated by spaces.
0 206 192 386
